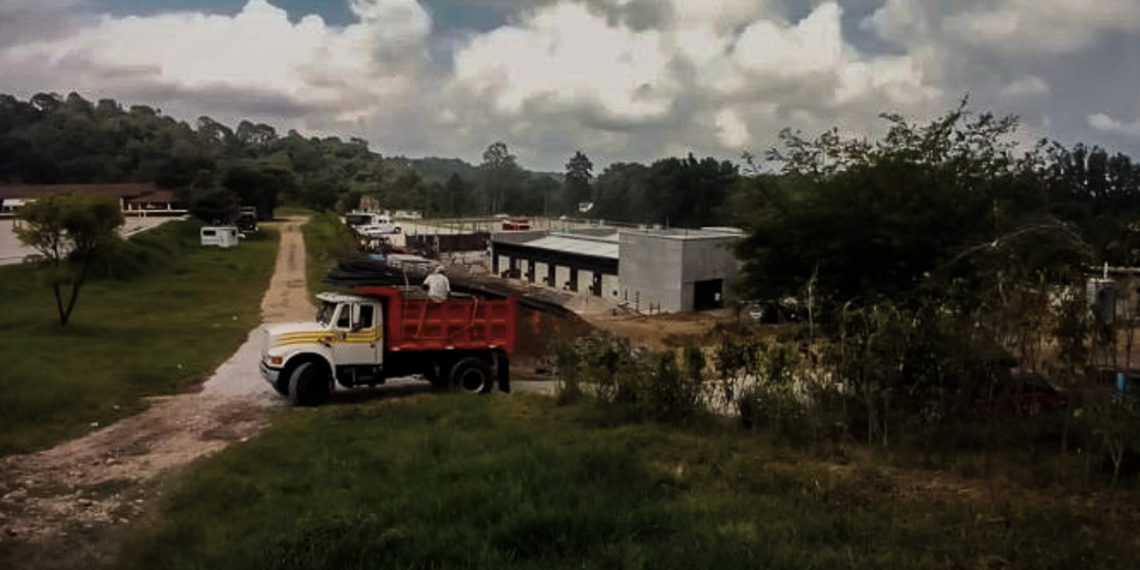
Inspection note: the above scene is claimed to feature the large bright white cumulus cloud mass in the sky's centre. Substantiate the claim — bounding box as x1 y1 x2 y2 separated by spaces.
446 0 942 164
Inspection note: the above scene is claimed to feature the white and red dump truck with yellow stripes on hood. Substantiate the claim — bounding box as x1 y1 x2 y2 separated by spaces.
259 285 519 406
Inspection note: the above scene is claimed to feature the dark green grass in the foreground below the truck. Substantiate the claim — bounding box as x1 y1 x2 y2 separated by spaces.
113 394 1138 569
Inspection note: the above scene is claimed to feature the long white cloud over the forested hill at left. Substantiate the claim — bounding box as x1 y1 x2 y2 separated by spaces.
0 0 431 120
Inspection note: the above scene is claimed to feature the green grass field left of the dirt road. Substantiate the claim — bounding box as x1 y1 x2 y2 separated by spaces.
0 221 277 455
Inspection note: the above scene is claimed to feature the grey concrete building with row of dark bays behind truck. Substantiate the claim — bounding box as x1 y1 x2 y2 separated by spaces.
491 228 742 312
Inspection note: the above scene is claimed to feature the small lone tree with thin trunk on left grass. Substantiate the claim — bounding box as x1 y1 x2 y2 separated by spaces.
16 194 123 325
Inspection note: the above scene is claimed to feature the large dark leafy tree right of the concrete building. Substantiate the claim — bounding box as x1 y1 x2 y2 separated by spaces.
738 104 1082 306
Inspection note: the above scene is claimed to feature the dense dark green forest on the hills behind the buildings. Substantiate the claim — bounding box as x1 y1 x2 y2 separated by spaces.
0 93 739 226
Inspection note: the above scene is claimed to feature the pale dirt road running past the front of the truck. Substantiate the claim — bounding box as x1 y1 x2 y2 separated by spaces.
0 218 314 568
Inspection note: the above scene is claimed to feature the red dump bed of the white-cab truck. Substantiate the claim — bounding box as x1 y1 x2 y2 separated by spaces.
357 285 519 355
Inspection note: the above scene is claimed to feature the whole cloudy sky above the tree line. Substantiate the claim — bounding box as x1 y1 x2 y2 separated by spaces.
0 0 1140 172
